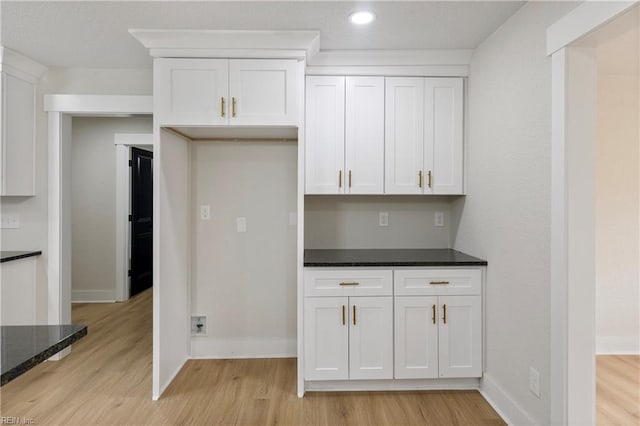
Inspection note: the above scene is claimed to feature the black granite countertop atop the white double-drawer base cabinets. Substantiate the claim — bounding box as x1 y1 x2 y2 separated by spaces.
304 249 487 267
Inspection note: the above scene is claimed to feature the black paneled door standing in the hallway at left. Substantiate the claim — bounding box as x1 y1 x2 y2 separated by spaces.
130 148 153 296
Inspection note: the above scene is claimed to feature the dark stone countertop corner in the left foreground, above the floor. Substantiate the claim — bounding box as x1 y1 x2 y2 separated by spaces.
0 324 87 386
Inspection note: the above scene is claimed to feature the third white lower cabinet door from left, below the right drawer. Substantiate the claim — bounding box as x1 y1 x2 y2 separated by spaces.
394 296 438 379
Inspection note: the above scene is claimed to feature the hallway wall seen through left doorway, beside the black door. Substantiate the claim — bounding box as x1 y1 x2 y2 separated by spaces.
71 117 153 301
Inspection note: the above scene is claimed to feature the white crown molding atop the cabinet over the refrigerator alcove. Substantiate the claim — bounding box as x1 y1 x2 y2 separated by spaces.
129 29 320 59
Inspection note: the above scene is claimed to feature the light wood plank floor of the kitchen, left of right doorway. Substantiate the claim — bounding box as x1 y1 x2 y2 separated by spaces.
0 291 505 426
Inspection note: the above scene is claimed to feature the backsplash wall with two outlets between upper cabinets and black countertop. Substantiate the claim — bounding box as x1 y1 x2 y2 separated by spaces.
304 195 459 249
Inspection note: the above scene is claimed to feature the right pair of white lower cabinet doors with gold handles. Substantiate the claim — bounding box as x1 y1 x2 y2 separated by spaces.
394 295 482 379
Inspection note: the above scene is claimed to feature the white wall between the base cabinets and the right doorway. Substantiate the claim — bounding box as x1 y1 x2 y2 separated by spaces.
453 2 576 424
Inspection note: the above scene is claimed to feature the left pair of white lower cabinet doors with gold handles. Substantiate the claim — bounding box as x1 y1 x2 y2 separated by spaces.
304 296 393 380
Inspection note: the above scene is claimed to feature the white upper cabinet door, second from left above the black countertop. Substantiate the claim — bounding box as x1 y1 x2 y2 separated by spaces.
345 77 384 194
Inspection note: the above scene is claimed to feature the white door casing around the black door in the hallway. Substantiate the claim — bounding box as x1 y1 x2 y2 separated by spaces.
113 133 153 302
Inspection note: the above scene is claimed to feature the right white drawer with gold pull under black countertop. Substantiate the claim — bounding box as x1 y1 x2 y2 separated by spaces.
394 269 482 296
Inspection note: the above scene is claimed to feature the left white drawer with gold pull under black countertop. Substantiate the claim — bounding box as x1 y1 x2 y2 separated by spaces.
304 268 393 297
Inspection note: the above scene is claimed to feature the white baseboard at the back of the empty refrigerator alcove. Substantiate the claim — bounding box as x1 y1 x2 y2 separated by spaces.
191 336 297 359
